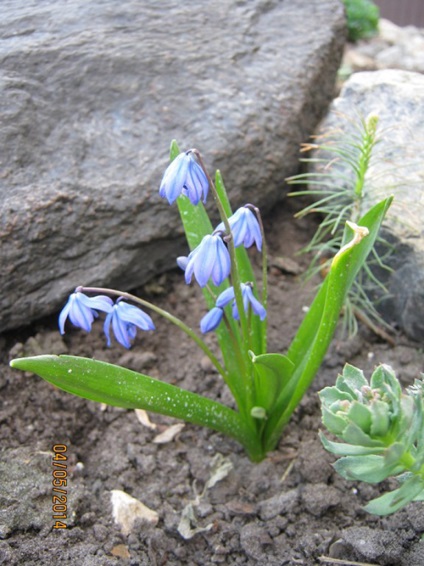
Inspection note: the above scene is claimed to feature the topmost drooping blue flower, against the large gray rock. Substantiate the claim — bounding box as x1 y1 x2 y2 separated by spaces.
159 151 209 204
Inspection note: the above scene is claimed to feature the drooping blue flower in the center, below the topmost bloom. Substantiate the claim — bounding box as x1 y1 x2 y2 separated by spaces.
177 234 231 287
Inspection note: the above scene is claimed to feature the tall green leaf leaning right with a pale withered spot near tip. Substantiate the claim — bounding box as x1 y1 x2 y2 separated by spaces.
265 198 392 450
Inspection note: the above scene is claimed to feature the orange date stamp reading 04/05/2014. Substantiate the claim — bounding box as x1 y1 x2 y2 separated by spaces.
52 444 68 529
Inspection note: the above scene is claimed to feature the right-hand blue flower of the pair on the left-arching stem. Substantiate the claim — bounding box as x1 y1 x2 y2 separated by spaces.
103 299 155 348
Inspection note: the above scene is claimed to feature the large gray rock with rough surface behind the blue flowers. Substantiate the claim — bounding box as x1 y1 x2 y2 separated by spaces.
0 0 344 330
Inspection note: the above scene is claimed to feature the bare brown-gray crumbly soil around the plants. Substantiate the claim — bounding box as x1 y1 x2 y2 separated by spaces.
0 193 424 566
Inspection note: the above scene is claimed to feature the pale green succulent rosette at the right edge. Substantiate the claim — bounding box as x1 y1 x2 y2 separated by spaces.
319 364 424 515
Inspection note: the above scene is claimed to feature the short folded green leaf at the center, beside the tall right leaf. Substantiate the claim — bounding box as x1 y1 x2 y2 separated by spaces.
252 353 294 413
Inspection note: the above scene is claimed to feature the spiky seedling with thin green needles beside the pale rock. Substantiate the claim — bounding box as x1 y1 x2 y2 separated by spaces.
288 115 392 336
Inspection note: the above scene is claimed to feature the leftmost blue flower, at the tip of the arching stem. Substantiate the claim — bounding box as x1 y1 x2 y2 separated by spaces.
59 291 113 334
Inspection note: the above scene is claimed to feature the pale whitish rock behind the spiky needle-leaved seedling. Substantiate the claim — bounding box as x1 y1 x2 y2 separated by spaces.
312 70 424 341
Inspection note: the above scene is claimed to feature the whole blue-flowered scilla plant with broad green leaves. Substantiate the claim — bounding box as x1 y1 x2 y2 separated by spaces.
11 141 391 461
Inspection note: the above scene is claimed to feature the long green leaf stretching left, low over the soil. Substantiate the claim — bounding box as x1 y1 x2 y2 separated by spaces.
10 356 250 452
